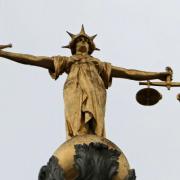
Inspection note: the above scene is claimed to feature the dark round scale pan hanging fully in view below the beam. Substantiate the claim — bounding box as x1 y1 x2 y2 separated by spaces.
136 88 162 106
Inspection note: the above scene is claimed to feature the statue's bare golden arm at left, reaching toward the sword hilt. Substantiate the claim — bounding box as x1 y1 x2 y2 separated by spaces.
0 50 54 72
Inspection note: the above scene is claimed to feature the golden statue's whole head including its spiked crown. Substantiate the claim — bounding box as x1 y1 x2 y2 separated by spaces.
63 25 99 55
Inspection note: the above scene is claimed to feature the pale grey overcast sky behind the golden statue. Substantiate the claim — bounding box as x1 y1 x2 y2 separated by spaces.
0 0 180 180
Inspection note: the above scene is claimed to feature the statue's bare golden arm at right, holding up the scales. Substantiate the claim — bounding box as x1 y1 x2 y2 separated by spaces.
111 66 170 81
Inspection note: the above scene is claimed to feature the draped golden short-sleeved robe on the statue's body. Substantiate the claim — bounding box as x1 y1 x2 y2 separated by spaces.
50 55 112 138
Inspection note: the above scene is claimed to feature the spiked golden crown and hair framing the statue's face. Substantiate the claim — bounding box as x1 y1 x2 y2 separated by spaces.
62 25 100 54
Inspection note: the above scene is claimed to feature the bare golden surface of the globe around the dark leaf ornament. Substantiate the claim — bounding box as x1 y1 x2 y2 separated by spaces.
54 135 130 180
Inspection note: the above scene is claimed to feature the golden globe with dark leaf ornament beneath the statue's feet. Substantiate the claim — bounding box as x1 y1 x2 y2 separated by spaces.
39 135 136 180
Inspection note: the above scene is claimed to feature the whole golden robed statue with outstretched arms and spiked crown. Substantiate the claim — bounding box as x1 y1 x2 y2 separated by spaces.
0 26 170 138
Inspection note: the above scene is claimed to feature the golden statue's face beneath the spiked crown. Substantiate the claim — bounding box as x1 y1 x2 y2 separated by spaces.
76 37 89 54
